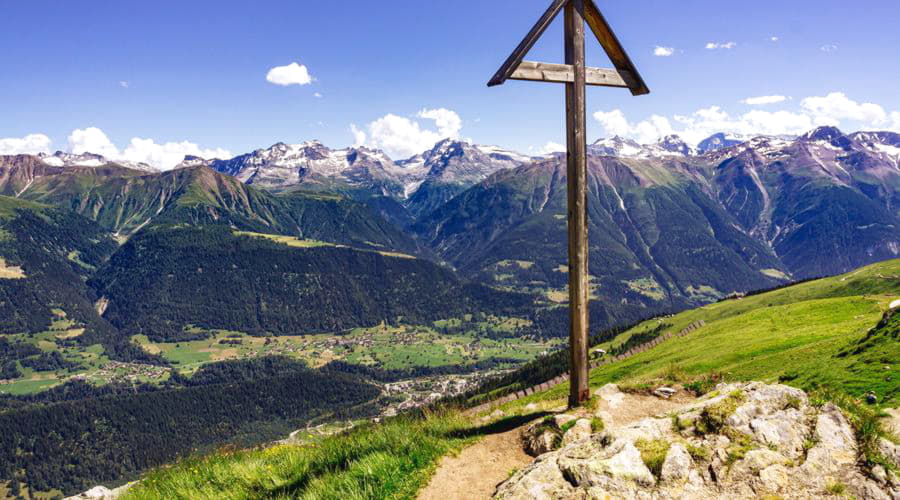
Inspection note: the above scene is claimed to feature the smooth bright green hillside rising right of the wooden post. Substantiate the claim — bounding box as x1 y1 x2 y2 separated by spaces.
492 260 900 406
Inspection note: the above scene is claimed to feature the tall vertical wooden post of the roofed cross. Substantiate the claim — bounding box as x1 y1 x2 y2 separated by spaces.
565 0 590 407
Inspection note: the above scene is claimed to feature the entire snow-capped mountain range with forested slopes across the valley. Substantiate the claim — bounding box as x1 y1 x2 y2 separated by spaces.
0 127 900 356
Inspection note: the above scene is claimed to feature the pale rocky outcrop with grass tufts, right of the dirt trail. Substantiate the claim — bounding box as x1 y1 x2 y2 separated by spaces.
495 382 900 500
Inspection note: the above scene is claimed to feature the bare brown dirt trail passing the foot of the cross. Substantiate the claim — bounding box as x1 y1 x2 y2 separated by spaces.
418 390 695 500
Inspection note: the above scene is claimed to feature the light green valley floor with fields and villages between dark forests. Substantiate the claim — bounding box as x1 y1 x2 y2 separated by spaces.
0 309 561 395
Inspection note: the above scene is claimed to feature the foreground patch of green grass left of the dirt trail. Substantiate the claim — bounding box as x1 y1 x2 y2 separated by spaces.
123 413 475 500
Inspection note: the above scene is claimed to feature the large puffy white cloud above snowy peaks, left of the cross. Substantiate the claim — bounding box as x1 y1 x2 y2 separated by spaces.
350 108 462 158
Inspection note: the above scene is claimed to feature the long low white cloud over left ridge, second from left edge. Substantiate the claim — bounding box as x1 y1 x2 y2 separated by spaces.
69 127 233 170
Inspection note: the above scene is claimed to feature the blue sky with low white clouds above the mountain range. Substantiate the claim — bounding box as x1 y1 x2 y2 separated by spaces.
0 0 900 168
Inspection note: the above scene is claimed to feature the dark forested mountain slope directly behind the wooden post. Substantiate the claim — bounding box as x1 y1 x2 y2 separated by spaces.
414 156 784 308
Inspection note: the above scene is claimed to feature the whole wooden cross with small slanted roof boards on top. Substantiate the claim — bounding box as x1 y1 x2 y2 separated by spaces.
488 0 650 407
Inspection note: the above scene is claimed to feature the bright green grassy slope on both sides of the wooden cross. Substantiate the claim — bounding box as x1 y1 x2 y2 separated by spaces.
121 260 900 499
